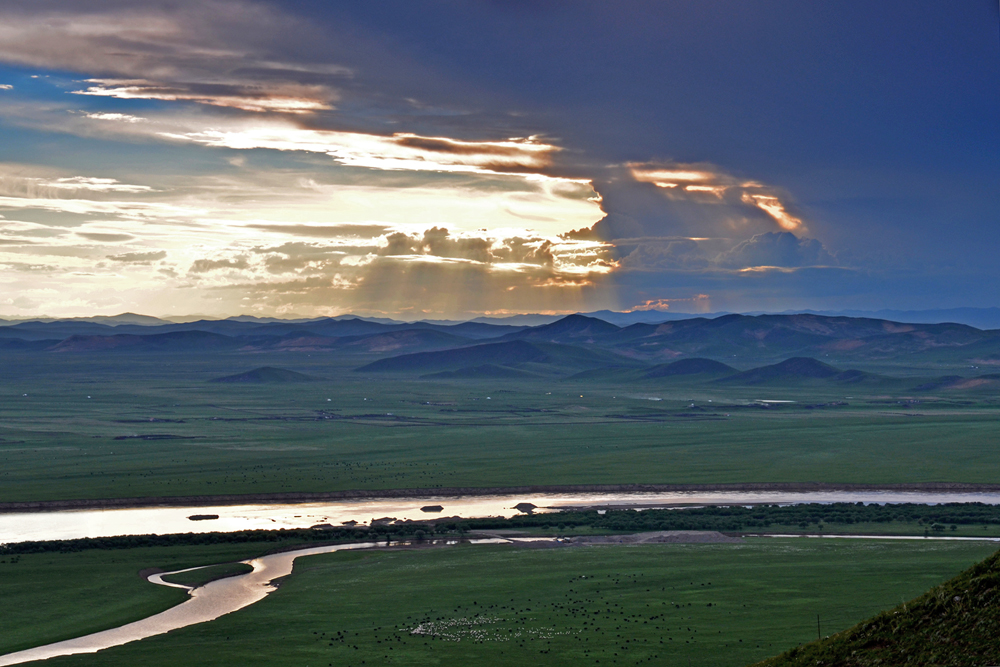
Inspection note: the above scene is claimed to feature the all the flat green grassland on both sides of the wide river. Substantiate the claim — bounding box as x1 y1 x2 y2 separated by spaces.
0 353 1000 667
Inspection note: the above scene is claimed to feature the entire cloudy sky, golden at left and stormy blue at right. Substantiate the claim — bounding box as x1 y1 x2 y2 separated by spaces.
0 0 1000 319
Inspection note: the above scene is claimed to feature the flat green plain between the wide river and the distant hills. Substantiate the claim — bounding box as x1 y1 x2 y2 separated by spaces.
0 353 1000 502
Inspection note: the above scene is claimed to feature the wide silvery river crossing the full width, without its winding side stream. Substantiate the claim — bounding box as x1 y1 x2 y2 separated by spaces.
0 491 1000 544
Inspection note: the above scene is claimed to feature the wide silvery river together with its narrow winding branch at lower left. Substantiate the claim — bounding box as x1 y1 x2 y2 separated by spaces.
0 490 1000 667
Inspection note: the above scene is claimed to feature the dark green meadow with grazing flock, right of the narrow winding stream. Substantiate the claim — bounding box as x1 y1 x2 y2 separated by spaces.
17 539 993 667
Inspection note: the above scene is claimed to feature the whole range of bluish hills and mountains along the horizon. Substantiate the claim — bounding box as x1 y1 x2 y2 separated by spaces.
0 314 1000 387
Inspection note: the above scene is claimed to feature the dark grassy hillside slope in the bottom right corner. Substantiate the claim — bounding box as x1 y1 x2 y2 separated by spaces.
758 552 1000 667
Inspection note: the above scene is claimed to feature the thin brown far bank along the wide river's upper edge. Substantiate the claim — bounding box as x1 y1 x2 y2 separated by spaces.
0 482 1000 513
